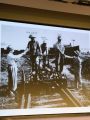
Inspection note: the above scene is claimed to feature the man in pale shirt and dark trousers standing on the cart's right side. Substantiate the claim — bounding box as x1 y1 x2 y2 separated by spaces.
53 35 64 73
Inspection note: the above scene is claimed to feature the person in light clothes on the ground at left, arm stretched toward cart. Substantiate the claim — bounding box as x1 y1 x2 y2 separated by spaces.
7 47 27 95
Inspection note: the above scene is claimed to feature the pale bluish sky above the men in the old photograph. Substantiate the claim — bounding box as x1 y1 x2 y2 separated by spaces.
0 21 90 51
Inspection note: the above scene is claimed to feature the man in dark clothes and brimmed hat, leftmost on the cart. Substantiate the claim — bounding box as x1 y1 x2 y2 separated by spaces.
27 35 40 71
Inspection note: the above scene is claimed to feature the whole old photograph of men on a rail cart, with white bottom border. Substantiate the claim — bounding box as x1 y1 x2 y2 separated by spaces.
0 20 90 116
